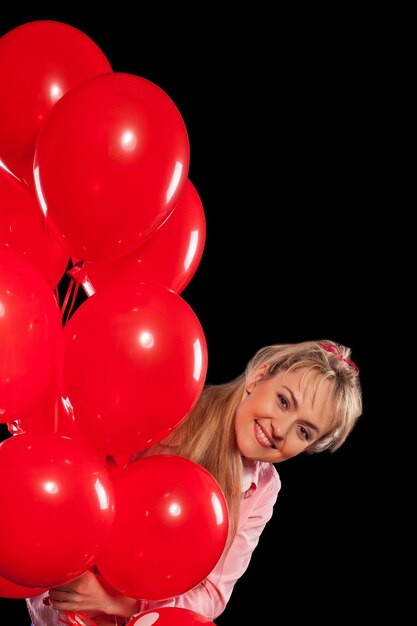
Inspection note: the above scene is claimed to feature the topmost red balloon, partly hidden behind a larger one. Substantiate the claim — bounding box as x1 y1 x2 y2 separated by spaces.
0 20 111 187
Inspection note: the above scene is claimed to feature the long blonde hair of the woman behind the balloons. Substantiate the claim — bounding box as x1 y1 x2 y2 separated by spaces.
165 340 362 545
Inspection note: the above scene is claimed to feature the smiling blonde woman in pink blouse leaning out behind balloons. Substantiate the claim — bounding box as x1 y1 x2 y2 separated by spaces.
27 340 362 626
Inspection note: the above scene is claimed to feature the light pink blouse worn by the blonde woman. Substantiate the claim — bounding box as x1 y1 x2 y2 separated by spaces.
26 461 281 626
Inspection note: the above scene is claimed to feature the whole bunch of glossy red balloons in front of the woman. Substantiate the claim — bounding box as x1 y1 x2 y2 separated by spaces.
0 20 228 624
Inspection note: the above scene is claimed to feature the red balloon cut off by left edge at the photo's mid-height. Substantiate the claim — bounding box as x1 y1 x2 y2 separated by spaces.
0 247 61 422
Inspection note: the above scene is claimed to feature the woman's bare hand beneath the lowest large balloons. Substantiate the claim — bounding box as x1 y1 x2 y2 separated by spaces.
49 571 138 617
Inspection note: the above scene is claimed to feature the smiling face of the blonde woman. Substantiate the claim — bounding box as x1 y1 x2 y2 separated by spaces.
235 367 333 463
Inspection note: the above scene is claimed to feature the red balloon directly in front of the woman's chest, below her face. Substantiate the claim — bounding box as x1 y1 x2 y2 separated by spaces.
96 454 229 600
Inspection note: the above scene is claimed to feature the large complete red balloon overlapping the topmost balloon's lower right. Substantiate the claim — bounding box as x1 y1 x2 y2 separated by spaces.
34 72 190 261
